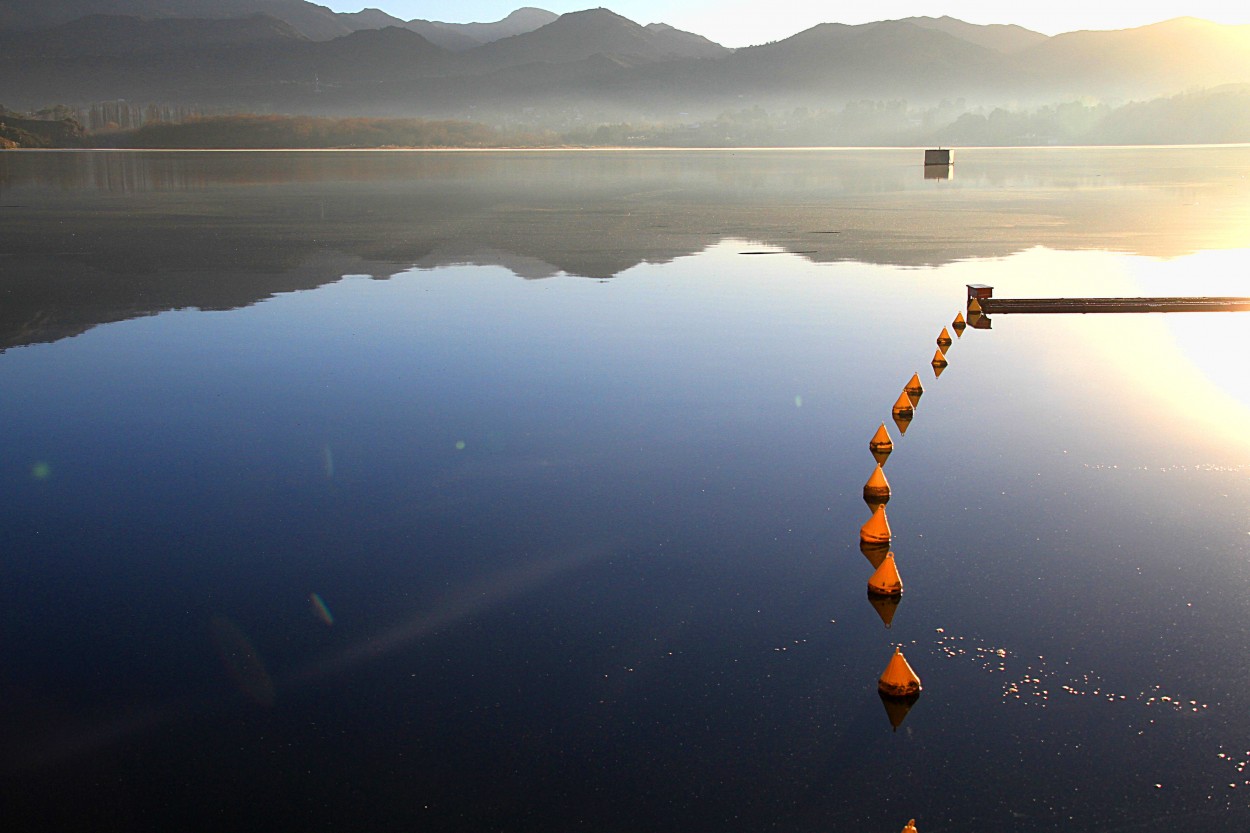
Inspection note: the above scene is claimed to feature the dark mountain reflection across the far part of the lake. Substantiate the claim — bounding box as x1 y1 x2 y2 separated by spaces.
0 148 1250 348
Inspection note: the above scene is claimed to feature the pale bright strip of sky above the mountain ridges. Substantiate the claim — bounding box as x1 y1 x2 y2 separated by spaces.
314 0 1250 46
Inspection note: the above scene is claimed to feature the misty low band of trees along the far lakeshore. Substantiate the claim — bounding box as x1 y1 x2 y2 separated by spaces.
0 85 1250 150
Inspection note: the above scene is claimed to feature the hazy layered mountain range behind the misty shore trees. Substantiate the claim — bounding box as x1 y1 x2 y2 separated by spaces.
0 0 1250 128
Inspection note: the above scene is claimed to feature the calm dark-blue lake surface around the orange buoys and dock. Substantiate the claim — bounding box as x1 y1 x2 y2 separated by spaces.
7 148 1250 833
